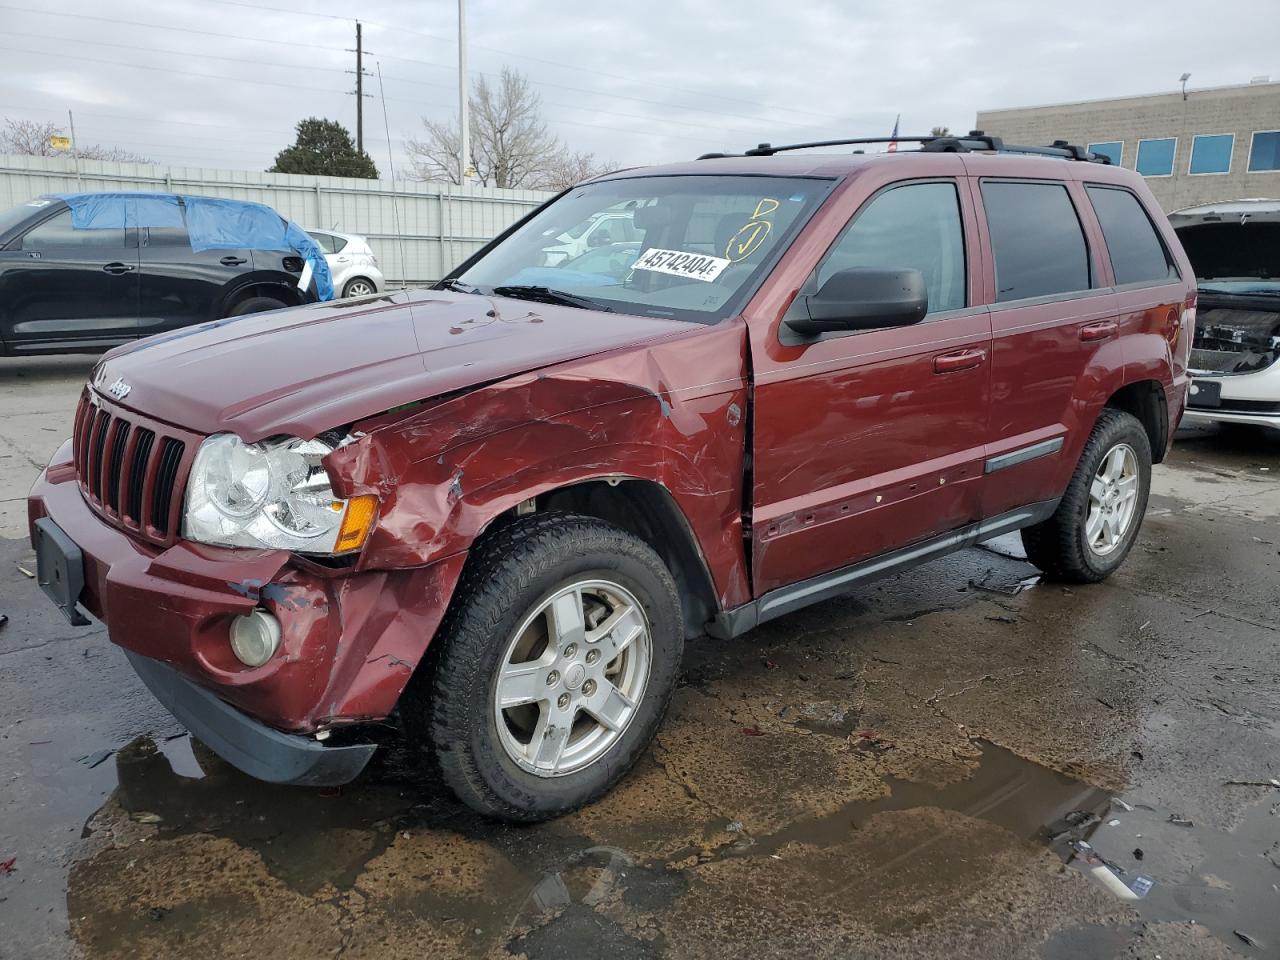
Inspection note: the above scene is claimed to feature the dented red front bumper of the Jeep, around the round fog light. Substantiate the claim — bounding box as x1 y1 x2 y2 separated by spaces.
28 442 466 733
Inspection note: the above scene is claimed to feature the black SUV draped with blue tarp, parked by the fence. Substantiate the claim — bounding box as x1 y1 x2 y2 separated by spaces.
0 197 315 356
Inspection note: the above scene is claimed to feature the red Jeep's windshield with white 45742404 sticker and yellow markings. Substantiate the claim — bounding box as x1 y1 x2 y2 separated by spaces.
456 175 835 323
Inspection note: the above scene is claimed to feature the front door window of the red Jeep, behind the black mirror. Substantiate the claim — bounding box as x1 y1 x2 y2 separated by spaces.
814 180 966 315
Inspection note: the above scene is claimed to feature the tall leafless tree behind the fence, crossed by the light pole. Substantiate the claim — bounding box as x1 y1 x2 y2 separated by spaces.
407 67 608 188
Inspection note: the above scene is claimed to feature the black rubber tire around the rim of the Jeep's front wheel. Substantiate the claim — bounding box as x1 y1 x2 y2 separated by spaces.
433 531 684 819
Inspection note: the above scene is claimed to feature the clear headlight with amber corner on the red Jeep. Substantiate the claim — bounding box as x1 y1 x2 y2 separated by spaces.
182 434 376 554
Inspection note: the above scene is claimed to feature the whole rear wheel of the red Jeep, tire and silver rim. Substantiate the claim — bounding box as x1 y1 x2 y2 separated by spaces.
1021 407 1151 584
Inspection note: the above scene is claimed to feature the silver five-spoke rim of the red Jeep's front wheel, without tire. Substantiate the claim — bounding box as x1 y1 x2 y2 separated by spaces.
493 580 653 777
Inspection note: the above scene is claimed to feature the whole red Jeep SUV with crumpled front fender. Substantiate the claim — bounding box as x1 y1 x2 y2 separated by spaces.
29 134 1196 820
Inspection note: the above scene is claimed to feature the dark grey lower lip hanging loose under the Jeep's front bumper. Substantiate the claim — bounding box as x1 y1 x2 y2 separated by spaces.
125 650 378 786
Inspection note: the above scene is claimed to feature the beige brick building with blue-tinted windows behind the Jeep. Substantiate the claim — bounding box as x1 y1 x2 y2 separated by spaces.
977 78 1280 211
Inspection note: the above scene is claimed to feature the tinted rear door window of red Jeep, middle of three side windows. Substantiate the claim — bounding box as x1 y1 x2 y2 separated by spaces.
982 180 1089 302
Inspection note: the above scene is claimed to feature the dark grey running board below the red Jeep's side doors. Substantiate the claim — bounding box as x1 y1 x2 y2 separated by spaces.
707 500 1057 640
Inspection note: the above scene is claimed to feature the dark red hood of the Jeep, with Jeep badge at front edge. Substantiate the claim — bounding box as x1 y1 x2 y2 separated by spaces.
92 291 692 442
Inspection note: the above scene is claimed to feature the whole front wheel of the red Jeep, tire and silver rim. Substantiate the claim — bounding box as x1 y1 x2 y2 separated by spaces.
401 512 684 822
